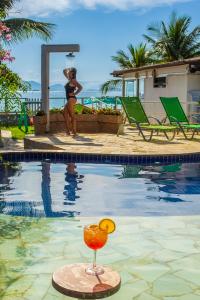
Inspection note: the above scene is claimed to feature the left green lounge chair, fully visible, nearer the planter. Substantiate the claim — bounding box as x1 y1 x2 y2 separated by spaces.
120 97 177 142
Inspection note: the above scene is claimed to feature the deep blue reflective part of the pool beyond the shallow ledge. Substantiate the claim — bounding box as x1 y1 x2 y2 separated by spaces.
0 161 200 218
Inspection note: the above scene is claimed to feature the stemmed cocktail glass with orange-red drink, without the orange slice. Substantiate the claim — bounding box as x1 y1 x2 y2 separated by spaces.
84 225 108 275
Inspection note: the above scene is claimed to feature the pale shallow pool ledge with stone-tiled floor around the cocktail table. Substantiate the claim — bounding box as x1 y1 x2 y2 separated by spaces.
0 216 200 300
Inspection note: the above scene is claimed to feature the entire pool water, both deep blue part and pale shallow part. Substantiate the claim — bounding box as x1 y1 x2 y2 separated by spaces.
0 161 200 300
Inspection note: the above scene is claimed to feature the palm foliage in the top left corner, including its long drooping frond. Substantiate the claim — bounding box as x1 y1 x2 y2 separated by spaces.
0 0 55 43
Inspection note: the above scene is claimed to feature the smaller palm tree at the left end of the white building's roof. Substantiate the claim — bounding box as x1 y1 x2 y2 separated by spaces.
101 43 154 96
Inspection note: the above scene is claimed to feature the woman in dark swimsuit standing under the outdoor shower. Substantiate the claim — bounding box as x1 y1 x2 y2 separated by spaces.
63 68 82 136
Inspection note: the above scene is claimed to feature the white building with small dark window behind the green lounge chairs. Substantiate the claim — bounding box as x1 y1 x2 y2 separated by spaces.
123 65 200 120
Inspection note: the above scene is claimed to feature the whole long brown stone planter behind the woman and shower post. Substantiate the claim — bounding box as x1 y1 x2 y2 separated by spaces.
34 113 123 135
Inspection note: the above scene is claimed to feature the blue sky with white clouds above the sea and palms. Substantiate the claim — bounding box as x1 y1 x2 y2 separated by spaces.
7 0 200 88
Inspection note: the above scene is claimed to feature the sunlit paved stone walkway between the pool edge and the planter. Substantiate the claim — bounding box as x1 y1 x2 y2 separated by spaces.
0 128 200 155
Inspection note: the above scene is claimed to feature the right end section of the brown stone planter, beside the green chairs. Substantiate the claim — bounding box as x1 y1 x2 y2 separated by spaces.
98 114 123 134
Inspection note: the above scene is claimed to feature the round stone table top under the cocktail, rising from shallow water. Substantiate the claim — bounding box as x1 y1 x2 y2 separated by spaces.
52 264 121 299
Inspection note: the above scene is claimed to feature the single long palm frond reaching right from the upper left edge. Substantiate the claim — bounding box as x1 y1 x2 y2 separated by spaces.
4 18 55 43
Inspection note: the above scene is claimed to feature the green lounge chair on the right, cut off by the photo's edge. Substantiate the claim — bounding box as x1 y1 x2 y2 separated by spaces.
160 97 200 140
